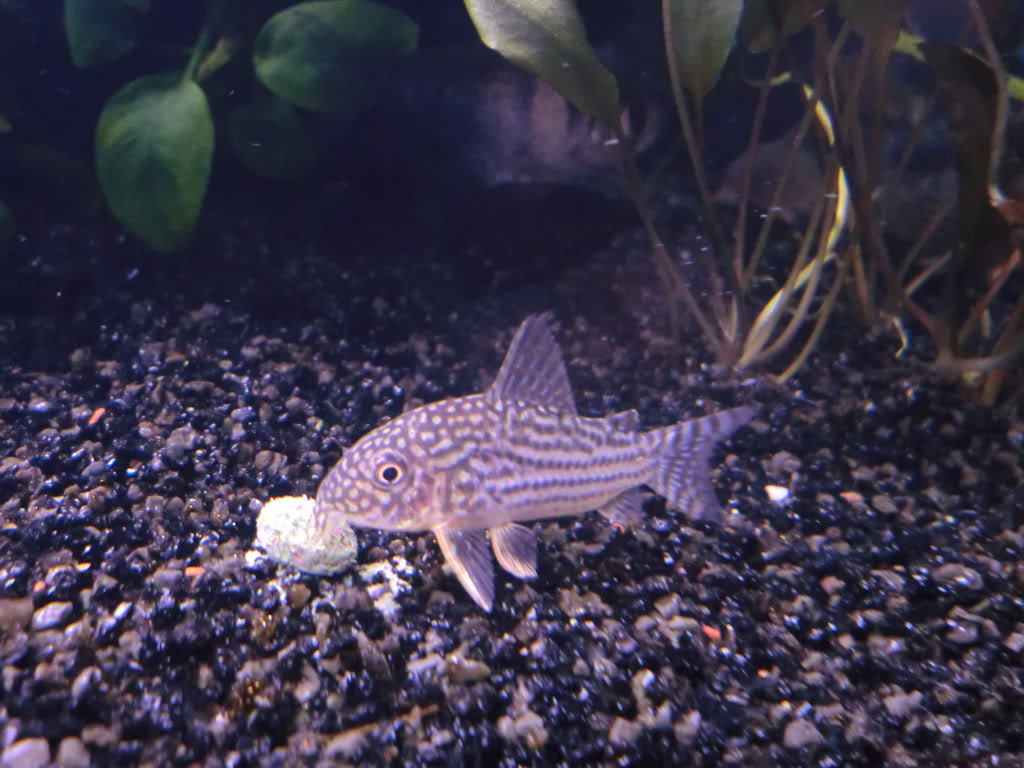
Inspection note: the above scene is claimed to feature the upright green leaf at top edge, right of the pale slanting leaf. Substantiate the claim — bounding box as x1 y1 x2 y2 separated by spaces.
669 0 743 98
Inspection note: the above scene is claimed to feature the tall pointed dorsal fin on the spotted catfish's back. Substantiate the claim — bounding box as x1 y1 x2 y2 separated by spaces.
486 312 577 414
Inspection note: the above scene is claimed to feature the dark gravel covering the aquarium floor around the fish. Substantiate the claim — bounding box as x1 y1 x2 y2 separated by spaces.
0 199 1024 768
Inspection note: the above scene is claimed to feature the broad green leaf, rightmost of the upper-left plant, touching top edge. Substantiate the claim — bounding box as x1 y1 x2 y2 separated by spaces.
253 0 420 114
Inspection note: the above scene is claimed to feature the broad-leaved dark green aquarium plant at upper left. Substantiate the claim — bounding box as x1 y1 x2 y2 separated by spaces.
65 0 419 251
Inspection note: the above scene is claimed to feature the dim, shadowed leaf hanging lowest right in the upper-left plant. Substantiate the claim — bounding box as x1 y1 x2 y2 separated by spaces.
228 95 319 181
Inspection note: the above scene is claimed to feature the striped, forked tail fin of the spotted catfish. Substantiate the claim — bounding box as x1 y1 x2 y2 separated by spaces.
647 407 756 521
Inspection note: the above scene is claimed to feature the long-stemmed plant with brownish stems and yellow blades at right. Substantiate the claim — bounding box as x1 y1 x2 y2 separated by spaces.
466 0 1024 402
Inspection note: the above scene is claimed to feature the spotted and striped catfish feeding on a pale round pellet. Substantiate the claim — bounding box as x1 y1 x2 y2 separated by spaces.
314 313 754 611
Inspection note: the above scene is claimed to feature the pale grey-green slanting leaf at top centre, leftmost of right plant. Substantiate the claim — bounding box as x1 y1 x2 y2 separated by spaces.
465 0 618 126
